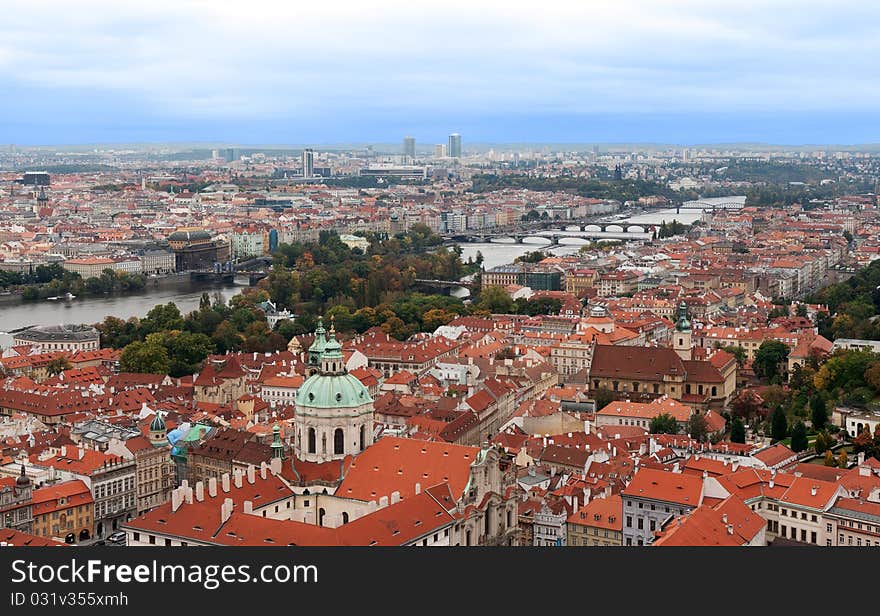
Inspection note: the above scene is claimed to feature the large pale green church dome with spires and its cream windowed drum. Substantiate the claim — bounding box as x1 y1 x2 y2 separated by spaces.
294 319 373 463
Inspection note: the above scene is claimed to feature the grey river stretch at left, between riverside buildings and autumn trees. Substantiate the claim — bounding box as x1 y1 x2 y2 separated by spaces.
0 279 245 348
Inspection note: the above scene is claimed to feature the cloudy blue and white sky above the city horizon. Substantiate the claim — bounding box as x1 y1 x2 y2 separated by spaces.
0 0 880 149
